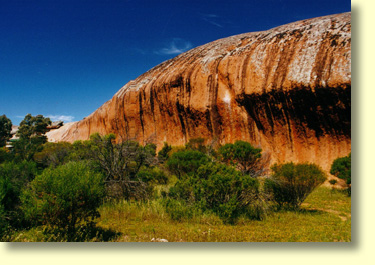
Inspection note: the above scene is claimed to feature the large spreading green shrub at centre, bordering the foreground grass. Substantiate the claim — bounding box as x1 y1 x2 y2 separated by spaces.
168 163 264 224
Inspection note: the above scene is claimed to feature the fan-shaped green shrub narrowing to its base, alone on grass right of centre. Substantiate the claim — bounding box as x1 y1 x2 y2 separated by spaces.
264 163 326 209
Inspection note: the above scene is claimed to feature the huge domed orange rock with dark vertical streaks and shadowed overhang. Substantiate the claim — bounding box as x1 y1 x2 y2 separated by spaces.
53 13 351 170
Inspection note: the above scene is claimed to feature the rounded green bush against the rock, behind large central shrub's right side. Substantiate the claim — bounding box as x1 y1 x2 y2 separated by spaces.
219 141 263 176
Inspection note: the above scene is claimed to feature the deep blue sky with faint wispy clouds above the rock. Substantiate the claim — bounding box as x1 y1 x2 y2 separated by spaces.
0 0 351 125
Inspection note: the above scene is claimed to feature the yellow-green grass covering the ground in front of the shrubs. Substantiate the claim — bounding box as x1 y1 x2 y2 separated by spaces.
8 187 351 242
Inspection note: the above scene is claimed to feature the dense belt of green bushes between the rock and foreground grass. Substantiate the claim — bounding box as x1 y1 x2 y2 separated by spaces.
0 115 341 241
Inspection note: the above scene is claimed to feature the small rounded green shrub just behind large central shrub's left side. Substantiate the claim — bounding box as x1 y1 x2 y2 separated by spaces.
167 150 210 179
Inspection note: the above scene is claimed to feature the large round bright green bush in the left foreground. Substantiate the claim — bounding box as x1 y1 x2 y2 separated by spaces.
21 159 104 240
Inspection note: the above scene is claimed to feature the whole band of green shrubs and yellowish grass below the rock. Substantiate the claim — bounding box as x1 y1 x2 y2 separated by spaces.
0 130 350 241
